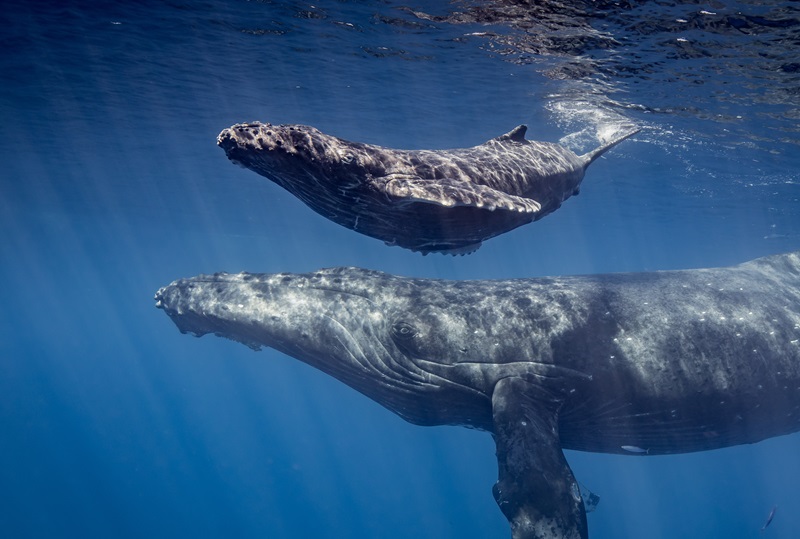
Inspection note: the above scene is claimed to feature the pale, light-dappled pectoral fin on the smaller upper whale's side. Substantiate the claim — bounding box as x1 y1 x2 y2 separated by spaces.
373 174 542 213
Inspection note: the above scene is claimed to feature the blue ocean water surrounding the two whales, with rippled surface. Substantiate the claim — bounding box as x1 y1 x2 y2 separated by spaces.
0 0 800 539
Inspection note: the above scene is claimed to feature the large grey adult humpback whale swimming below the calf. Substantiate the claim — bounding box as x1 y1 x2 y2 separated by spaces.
156 251 800 539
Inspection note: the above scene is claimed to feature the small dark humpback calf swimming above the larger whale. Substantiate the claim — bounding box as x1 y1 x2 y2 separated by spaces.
217 122 638 254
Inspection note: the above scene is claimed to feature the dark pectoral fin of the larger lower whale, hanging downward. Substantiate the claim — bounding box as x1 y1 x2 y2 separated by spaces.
492 377 589 539
